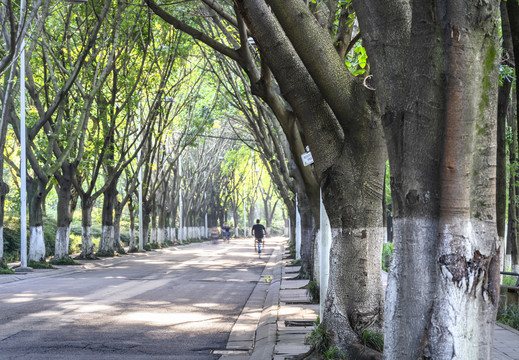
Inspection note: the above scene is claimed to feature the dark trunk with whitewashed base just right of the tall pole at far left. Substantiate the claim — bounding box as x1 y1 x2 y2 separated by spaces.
27 177 47 262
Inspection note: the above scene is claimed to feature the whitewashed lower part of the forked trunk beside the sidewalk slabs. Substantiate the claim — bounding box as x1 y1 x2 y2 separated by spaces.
323 227 385 344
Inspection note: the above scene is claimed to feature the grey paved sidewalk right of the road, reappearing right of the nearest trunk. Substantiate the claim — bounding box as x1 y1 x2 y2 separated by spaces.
237 242 519 360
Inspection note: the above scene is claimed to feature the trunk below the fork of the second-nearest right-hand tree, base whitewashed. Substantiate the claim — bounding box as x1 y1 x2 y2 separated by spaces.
323 146 386 358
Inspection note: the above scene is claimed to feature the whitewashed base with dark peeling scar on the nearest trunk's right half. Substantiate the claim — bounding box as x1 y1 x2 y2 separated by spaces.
425 219 499 360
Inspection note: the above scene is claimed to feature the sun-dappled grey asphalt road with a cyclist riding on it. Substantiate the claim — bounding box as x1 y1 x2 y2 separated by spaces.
0 239 273 360
